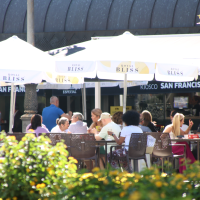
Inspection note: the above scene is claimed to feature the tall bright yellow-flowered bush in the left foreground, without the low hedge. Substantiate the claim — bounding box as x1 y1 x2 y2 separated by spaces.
0 134 77 200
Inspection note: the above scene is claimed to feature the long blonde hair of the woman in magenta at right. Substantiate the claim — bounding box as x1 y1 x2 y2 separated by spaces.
172 113 185 136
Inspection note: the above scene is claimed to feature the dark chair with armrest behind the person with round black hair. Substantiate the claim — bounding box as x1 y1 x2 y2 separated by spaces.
110 133 148 172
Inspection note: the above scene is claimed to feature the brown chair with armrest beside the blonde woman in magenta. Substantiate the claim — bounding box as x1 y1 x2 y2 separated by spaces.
145 132 186 171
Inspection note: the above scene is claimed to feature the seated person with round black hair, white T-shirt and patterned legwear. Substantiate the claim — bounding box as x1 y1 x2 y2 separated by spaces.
107 110 143 171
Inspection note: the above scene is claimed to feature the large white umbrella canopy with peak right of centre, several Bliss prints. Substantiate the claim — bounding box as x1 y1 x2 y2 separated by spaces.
52 32 198 82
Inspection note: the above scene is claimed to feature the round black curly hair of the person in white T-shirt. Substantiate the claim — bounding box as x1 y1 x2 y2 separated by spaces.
122 110 140 126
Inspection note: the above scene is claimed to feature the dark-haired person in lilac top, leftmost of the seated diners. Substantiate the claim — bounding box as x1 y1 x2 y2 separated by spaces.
27 114 49 137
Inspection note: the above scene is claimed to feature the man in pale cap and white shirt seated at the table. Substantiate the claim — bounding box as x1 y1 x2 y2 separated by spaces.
91 112 121 152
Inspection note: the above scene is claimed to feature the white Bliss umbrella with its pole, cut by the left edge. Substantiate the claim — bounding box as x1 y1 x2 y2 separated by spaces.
0 36 77 132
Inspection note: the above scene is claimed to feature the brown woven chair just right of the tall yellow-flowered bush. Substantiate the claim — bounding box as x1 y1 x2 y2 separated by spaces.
70 133 98 170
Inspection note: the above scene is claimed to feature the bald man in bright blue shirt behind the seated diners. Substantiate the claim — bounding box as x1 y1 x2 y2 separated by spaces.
42 96 71 131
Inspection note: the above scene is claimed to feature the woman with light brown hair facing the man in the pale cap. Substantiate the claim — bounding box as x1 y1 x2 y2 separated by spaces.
88 108 103 133
